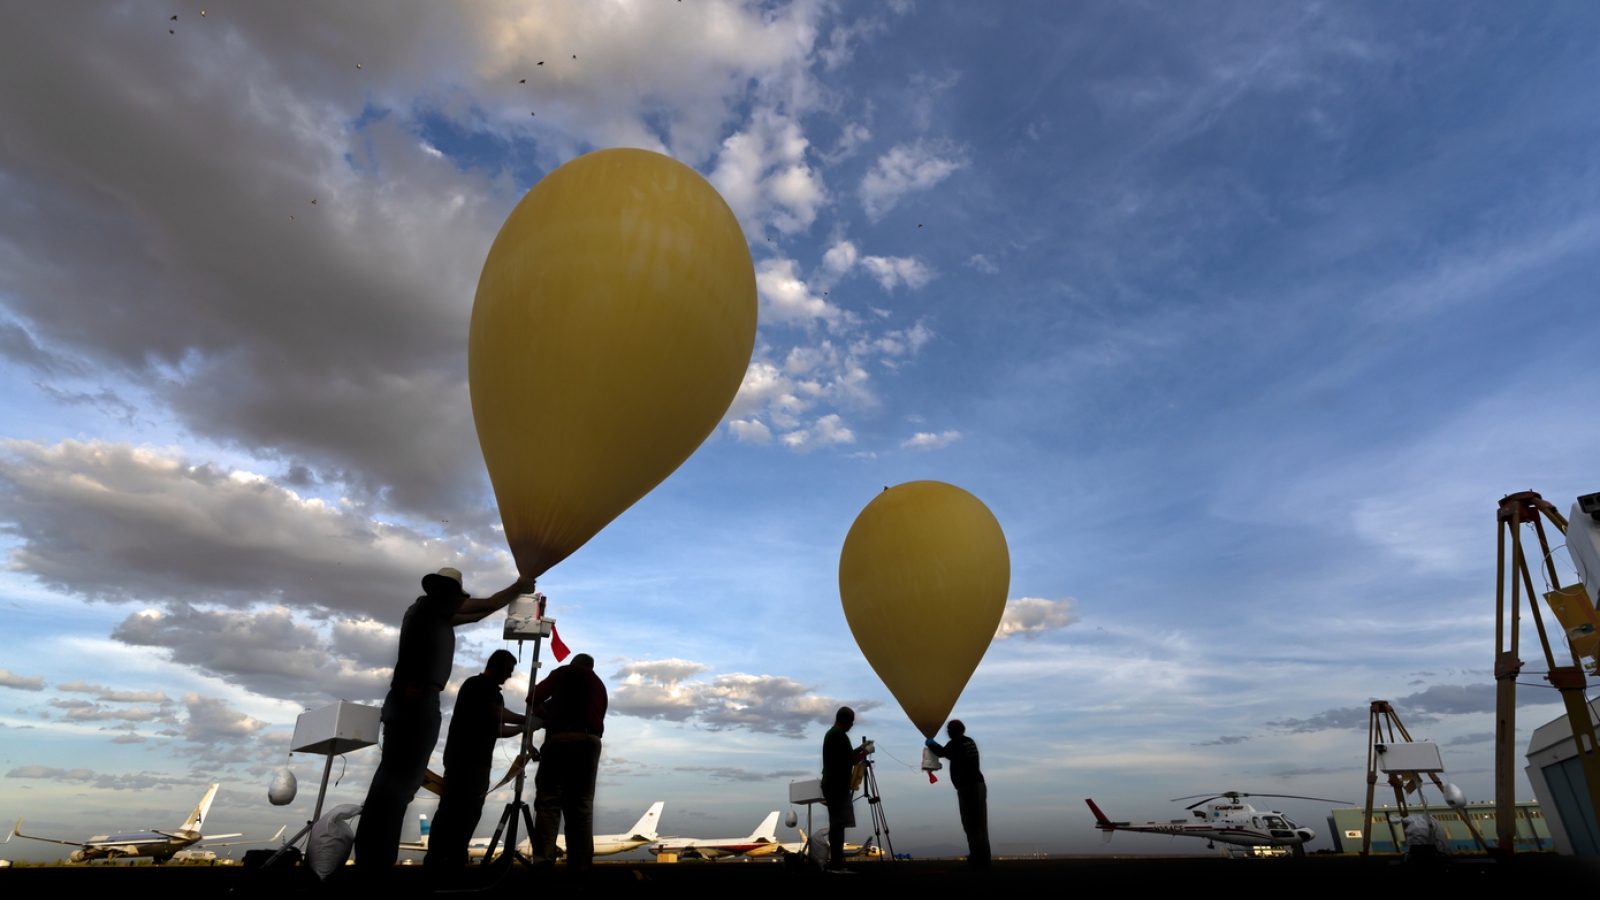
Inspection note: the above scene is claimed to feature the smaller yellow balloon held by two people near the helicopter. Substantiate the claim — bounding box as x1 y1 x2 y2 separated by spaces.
838 482 1011 737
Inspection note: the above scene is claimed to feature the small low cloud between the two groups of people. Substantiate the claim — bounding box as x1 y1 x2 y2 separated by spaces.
610 660 883 738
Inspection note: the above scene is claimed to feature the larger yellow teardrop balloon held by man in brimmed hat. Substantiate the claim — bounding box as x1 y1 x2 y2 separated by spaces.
467 149 755 577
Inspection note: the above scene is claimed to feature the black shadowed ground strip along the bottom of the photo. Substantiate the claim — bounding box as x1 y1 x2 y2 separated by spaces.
0 855 1600 900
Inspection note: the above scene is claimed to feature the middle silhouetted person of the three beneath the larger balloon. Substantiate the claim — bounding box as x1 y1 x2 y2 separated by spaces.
422 650 523 879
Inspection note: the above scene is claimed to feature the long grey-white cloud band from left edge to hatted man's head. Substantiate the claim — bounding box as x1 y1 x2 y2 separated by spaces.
0 440 514 617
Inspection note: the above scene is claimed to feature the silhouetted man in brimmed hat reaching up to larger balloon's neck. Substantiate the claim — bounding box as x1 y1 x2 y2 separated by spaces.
355 567 533 871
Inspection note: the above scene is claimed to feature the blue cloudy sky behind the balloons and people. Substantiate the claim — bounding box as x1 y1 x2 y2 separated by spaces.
0 0 1600 858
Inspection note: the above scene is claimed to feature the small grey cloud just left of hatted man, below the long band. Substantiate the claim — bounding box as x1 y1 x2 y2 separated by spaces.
110 604 400 703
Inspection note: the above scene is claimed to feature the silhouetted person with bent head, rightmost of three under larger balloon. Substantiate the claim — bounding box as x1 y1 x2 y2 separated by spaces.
533 653 608 873
